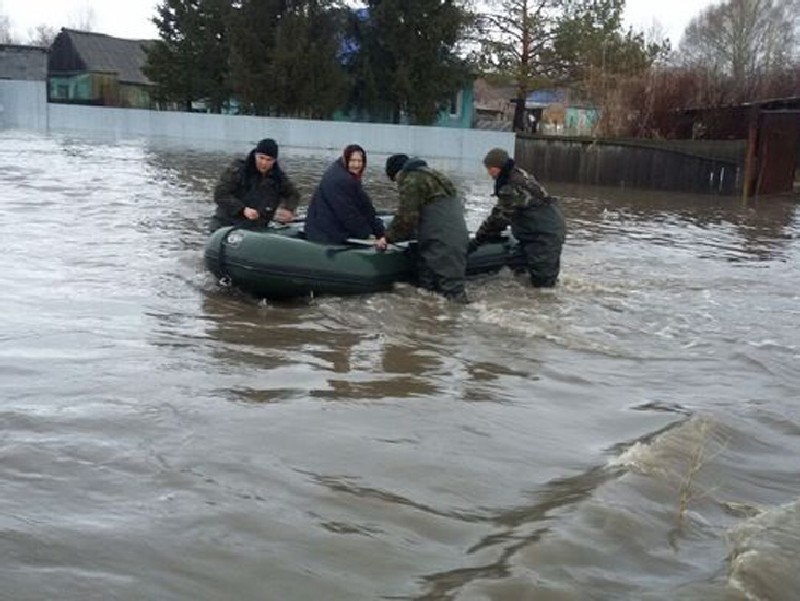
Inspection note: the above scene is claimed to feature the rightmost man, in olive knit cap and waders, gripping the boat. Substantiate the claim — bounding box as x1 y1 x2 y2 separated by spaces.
470 148 567 288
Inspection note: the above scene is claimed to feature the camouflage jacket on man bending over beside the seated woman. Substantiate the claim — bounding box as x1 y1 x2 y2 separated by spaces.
386 159 456 242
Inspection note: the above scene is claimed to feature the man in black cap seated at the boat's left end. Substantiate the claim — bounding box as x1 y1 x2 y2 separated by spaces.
210 138 300 232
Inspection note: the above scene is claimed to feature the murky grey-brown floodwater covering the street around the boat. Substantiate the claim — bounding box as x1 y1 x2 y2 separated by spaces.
0 131 800 601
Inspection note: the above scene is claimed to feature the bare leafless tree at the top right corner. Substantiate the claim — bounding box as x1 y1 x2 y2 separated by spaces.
680 0 800 101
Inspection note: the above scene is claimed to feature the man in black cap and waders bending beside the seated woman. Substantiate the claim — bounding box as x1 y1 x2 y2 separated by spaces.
386 154 469 303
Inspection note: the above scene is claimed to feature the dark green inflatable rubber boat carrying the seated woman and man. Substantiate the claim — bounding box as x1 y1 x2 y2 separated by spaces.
205 223 522 299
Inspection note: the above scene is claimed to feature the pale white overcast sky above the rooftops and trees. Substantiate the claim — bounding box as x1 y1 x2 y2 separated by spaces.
0 0 714 48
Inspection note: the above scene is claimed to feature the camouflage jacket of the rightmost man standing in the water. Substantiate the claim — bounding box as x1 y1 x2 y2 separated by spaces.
475 163 555 242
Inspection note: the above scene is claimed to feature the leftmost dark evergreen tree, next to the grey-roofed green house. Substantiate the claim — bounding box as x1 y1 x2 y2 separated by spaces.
143 0 231 113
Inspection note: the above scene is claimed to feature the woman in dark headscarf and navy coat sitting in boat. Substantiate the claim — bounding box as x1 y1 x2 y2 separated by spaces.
305 144 386 248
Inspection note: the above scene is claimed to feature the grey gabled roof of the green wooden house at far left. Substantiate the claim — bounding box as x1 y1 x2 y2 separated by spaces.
49 28 152 85
